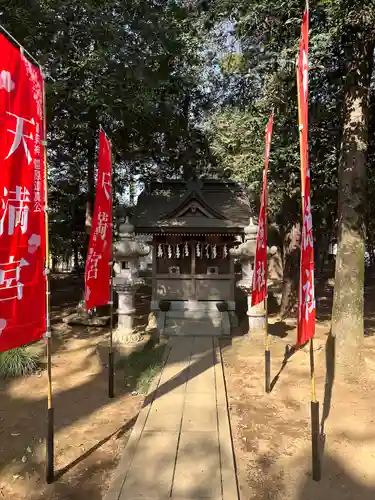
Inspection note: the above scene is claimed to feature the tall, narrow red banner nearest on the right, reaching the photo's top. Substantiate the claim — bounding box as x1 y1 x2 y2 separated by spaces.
297 10 315 346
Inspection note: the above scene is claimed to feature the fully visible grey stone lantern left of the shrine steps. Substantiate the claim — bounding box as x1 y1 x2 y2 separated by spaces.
113 217 150 346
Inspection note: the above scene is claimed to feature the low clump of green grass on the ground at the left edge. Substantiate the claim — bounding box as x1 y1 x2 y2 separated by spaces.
0 347 39 378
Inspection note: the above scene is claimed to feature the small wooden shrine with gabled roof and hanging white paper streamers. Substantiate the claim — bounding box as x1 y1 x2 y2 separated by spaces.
133 179 250 324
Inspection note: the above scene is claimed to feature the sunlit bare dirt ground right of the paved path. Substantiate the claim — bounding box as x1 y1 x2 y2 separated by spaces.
223 280 375 500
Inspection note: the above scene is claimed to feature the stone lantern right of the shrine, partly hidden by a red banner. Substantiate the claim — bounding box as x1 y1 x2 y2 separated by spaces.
230 217 277 332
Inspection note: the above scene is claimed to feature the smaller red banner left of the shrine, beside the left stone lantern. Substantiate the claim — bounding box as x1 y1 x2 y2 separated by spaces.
85 130 112 311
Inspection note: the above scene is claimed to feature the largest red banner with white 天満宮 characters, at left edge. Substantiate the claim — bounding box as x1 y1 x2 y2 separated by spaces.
0 35 46 352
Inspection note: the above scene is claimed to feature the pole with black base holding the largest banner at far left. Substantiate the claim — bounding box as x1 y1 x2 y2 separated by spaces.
43 77 55 484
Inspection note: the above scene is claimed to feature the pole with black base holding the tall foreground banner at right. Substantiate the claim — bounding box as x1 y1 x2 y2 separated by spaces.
296 51 321 481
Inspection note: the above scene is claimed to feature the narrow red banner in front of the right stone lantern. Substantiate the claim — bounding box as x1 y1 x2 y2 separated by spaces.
251 115 273 306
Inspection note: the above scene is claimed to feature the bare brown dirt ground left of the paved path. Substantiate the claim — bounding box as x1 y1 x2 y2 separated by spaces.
0 278 142 500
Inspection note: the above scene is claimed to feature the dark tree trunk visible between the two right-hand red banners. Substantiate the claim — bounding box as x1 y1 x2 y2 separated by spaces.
280 222 301 318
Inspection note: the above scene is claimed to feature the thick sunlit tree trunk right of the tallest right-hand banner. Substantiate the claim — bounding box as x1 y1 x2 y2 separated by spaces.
332 33 373 378
